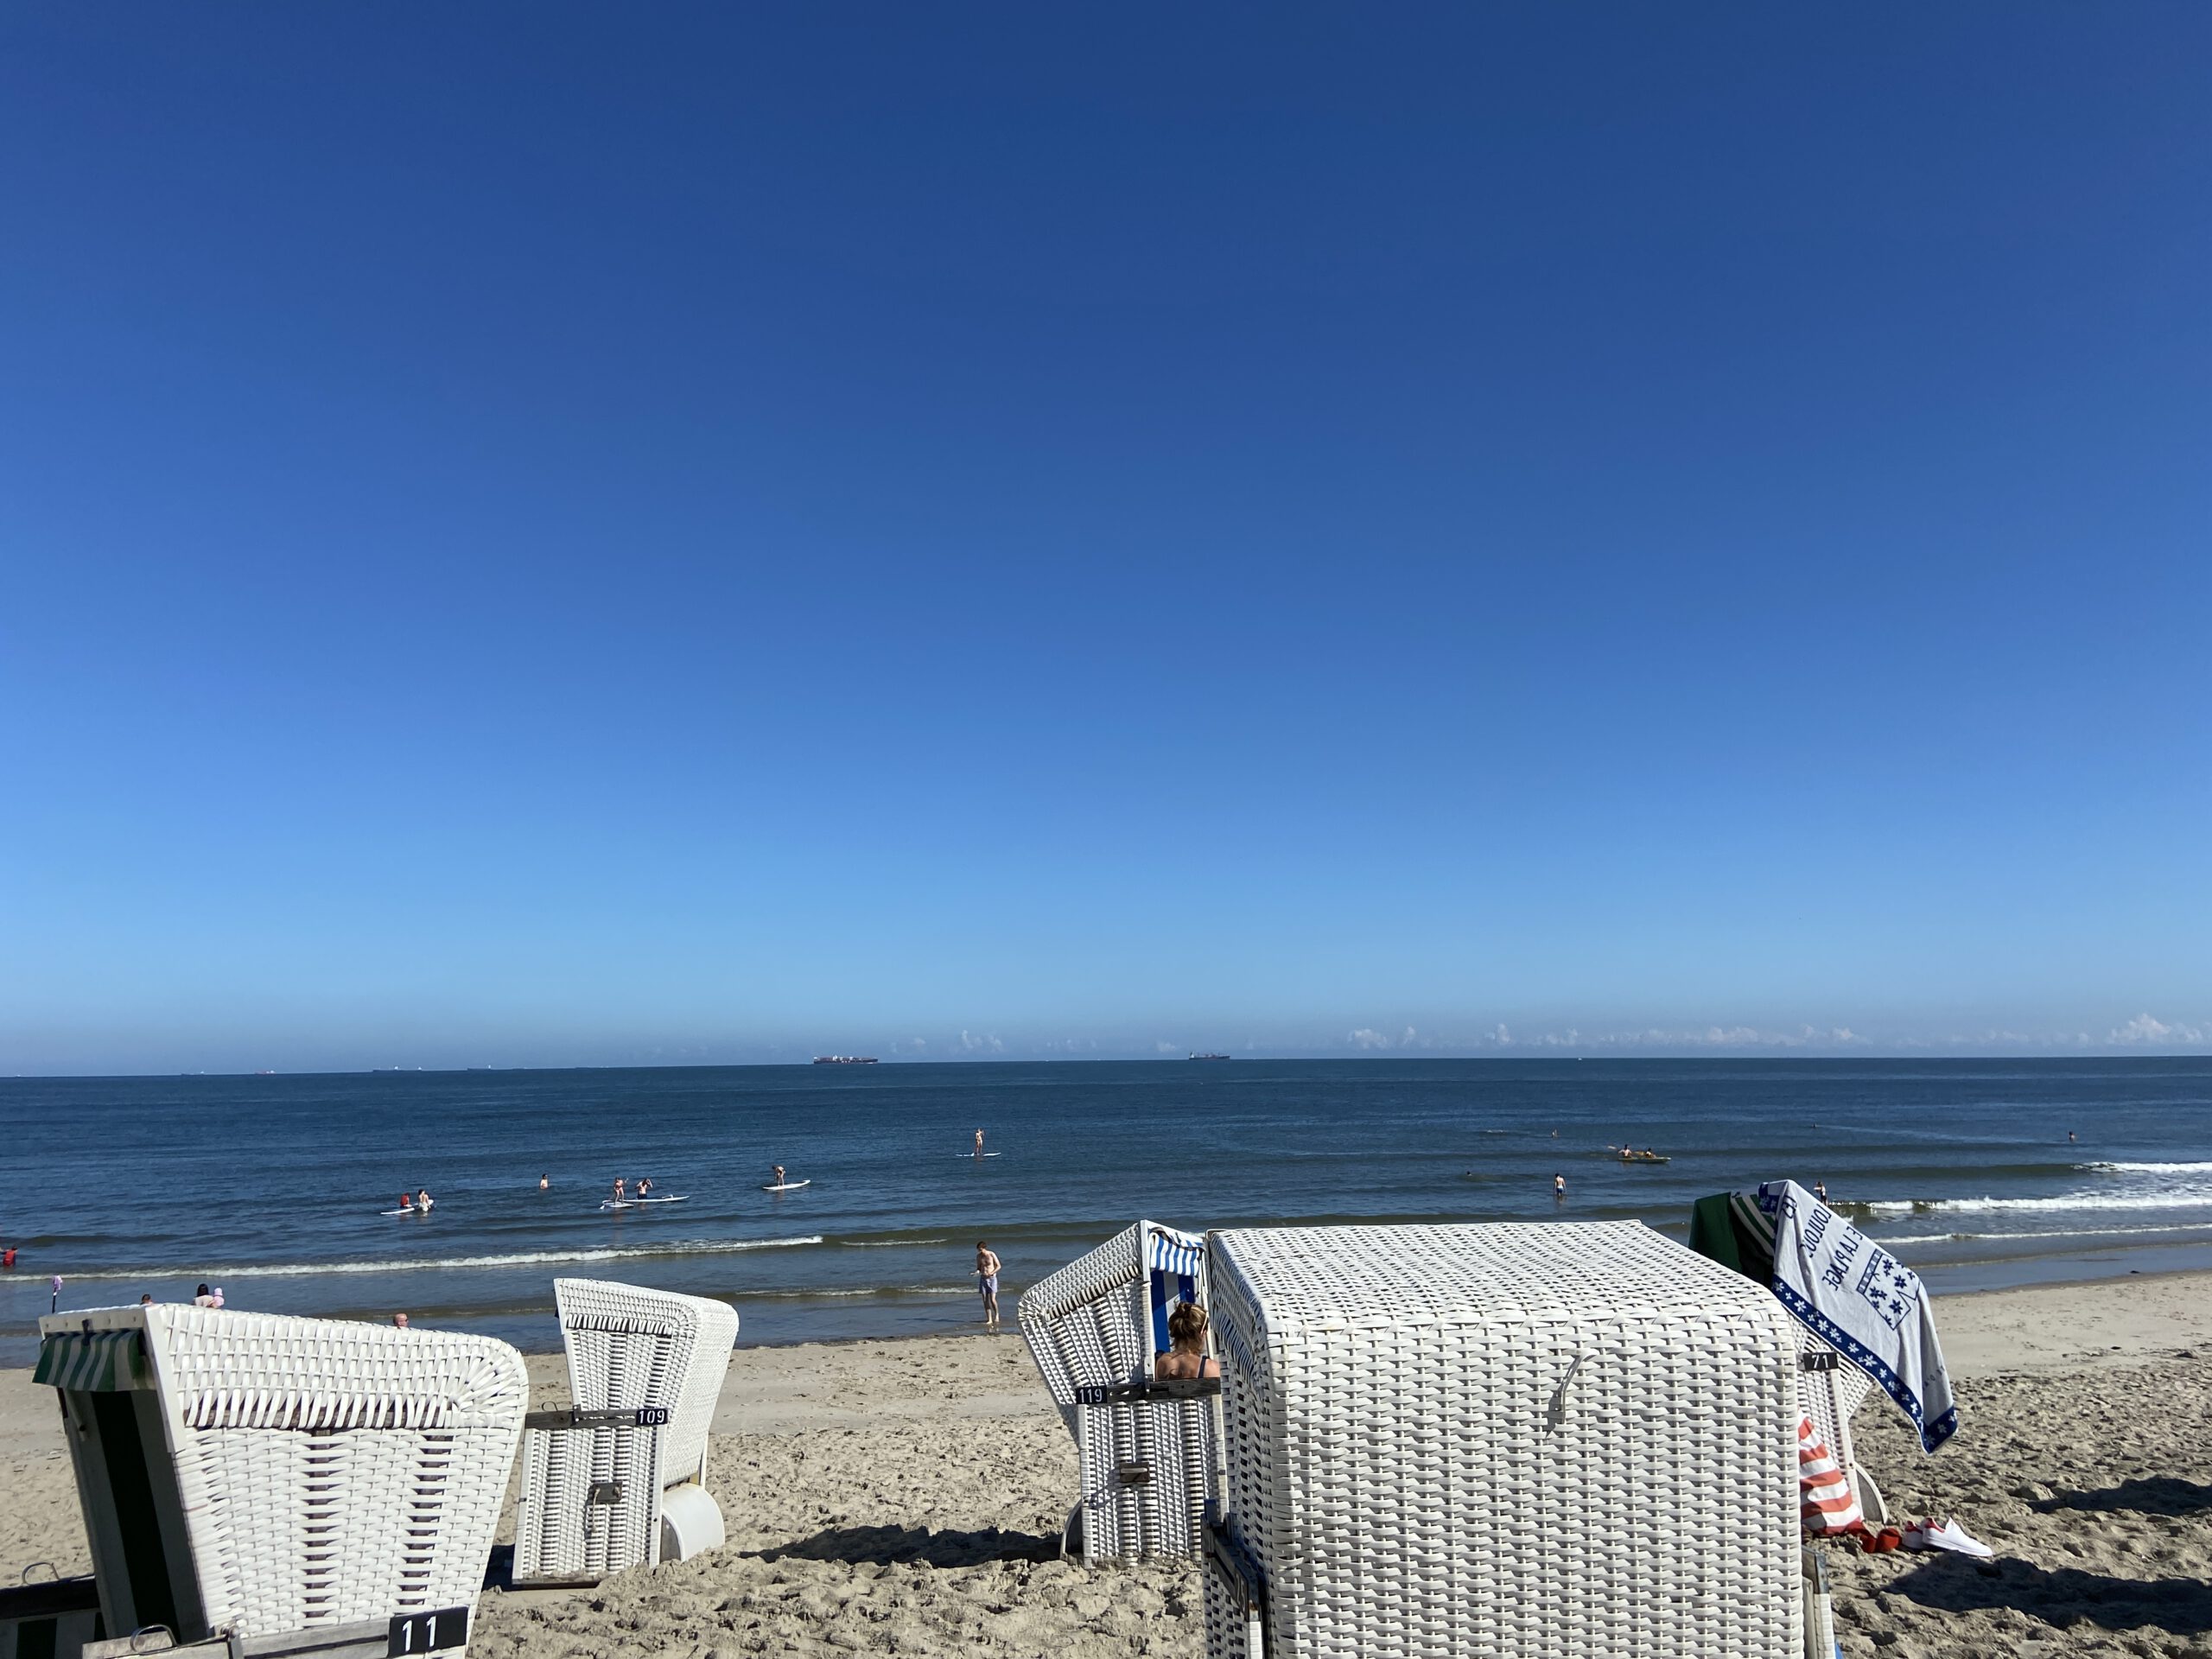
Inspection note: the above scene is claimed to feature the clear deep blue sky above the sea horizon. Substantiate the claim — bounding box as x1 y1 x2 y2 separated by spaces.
0 4 2212 1071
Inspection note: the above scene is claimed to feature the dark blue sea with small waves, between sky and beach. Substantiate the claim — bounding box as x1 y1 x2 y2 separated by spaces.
0 1059 2212 1365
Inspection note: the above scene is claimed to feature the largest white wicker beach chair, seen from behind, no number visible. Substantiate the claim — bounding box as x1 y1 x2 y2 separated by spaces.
1205 1221 1802 1659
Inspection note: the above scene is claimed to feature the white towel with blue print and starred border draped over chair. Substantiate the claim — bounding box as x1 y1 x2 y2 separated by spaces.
1757 1181 1958 1451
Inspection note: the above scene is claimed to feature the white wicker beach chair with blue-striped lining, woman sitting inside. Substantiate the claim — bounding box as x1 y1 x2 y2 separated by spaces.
1018 1221 1221 1564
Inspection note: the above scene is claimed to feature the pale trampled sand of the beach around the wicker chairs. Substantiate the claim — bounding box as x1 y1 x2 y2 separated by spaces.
0 1274 2212 1659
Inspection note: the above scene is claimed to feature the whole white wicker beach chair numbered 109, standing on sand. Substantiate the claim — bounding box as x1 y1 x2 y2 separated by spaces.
515 1279 736 1584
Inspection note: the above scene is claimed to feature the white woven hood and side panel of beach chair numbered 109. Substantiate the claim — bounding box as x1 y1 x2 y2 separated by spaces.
553 1279 736 1484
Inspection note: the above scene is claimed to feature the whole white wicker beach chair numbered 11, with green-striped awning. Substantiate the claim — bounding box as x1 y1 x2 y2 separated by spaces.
35 1303 529 1652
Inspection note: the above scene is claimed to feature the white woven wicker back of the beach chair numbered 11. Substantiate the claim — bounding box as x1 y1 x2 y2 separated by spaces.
55 1303 529 1637
